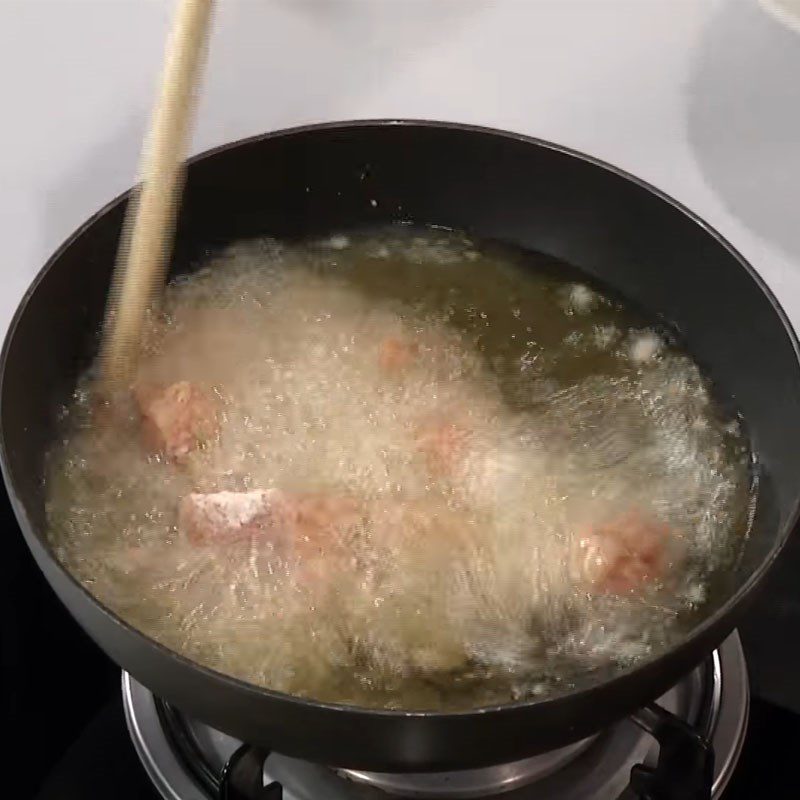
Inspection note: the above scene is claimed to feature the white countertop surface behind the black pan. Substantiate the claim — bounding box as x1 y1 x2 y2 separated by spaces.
0 0 800 330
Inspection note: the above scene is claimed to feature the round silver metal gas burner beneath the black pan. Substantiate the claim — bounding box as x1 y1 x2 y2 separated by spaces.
122 634 750 800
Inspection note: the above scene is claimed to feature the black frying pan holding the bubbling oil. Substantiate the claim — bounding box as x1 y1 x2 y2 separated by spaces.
0 122 800 771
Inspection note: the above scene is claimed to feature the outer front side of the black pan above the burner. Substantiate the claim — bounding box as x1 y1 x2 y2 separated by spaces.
1 504 764 772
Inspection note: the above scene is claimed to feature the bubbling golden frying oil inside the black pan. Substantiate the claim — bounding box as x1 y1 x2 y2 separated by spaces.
46 227 755 710
